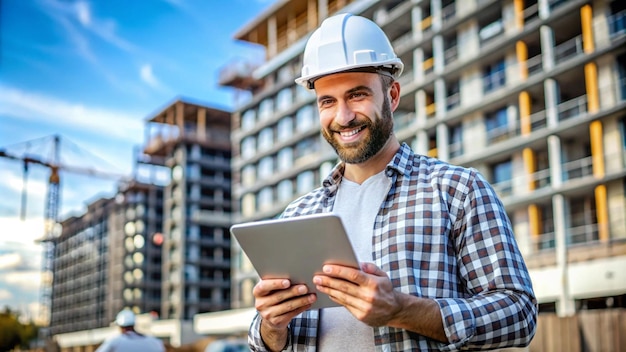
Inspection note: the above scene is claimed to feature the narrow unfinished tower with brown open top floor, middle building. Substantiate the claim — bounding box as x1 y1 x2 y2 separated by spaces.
143 100 232 320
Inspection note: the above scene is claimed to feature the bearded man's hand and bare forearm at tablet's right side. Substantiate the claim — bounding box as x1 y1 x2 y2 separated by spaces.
313 263 448 342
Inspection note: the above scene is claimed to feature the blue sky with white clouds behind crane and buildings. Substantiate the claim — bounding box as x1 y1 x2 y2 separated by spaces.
0 0 275 322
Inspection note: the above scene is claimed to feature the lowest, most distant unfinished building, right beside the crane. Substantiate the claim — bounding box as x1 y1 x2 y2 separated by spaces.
50 181 163 335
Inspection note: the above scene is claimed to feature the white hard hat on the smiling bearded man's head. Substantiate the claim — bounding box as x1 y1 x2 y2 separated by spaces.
296 13 404 89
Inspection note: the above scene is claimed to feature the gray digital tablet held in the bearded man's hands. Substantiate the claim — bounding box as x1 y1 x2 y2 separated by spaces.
230 213 359 309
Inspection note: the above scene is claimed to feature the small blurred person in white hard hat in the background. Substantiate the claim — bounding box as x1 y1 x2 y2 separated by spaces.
96 309 165 352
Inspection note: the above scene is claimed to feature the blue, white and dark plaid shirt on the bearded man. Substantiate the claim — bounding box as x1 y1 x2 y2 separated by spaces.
248 144 537 351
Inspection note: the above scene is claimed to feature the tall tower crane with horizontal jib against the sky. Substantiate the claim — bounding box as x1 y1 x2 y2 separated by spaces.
0 135 126 338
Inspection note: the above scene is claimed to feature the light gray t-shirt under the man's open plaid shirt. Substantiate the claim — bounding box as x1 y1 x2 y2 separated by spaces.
318 170 391 352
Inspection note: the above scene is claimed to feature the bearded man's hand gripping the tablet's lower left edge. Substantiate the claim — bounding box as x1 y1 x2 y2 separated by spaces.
252 279 317 351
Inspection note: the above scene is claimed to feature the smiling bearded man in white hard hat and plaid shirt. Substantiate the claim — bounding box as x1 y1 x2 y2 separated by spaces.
249 14 537 351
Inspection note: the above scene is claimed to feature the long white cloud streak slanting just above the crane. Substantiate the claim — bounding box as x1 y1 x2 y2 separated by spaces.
0 85 143 142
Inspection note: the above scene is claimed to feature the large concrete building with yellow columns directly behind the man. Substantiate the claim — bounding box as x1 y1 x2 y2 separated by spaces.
221 0 626 316
